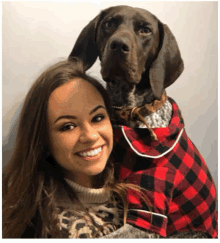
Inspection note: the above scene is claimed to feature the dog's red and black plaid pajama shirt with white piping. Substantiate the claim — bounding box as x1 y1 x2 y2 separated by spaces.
113 98 217 238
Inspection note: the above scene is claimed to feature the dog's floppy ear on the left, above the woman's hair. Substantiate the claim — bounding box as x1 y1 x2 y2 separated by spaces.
68 14 100 71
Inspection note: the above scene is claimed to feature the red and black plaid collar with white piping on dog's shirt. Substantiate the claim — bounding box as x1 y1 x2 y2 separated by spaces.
114 98 184 158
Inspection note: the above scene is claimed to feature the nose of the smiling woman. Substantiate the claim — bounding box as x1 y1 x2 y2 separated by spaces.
79 124 99 143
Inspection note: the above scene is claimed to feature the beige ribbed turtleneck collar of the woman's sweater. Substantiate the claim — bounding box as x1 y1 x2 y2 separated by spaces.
65 178 110 204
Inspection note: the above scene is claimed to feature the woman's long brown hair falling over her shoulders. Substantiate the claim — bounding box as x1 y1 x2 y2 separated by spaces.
2 60 150 238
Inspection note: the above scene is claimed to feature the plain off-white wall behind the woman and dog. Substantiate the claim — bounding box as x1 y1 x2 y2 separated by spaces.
2 0 218 193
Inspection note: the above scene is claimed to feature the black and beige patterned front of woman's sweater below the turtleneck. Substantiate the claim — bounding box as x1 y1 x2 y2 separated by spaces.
58 199 123 238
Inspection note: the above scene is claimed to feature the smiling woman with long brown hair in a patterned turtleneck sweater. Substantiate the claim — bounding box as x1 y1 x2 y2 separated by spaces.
3 61 150 238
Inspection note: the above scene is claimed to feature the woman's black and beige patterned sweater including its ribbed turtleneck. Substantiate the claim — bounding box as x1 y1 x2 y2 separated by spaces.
55 179 123 238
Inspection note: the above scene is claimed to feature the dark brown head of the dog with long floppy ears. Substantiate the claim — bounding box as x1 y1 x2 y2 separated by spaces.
69 6 183 103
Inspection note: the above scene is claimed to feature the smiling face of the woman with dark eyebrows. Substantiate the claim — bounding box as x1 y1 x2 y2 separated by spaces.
47 78 113 187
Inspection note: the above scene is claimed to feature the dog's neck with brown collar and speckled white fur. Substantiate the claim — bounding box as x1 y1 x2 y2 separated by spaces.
107 81 172 140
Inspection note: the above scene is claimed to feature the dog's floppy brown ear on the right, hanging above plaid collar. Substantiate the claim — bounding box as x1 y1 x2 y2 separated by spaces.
149 22 184 100
